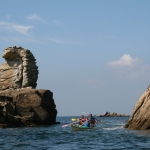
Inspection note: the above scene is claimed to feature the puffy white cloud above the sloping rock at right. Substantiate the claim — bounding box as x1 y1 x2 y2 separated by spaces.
107 54 150 79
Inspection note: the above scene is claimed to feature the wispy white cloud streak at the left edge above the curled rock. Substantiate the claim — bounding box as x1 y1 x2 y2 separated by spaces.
0 22 33 35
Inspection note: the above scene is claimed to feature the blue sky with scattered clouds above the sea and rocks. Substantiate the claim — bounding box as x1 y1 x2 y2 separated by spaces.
0 0 150 116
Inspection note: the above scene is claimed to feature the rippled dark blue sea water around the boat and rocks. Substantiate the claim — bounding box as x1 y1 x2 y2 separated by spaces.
0 116 150 150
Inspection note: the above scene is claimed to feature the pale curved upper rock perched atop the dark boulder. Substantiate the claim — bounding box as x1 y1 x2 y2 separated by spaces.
0 46 38 90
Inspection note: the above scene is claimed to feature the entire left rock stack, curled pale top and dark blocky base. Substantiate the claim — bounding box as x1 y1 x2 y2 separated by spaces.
0 46 57 127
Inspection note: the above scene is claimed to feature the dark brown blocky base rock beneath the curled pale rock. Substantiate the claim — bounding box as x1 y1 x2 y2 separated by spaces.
0 88 57 127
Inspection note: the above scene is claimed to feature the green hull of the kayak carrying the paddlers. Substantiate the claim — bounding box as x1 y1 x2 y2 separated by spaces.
71 124 96 131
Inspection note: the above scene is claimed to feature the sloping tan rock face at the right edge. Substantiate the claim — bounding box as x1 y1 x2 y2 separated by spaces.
124 86 150 130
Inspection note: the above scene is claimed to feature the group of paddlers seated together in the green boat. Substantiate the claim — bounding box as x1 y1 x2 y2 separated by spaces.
73 114 98 127
